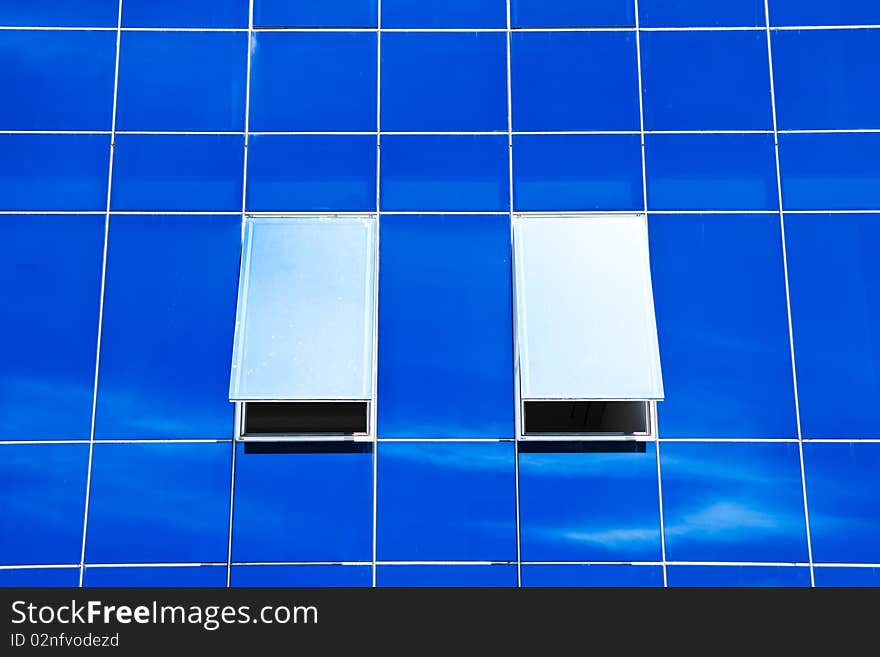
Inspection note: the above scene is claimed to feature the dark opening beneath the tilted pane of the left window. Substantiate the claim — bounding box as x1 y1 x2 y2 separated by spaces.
244 402 370 436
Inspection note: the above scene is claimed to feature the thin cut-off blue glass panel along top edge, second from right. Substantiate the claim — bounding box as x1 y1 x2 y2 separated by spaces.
639 0 768 26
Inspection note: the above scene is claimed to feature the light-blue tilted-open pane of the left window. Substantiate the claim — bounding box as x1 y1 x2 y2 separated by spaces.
229 217 376 400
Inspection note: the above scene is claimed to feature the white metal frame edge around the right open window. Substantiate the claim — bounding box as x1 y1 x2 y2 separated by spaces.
511 212 663 442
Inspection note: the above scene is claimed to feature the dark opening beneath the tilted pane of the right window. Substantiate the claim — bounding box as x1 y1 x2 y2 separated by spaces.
523 401 648 435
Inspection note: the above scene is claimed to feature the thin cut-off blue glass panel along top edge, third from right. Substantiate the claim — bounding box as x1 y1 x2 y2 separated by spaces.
510 0 635 27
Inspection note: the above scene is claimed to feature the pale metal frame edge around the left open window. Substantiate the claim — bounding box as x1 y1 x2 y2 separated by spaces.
230 212 379 443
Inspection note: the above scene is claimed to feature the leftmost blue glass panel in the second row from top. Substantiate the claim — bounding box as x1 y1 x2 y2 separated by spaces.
0 31 116 130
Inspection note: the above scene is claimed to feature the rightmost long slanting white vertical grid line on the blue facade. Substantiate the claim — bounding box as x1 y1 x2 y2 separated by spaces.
764 0 816 587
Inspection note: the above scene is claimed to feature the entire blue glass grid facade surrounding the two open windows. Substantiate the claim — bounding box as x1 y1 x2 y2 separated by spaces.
0 0 880 587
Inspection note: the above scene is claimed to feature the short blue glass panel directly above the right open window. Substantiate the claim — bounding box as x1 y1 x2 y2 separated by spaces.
513 135 644 212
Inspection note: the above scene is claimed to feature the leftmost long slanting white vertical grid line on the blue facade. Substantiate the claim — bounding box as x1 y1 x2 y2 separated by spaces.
78 0 122 587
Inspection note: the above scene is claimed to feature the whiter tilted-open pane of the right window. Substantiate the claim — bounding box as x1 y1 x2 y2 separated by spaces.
514 215 663 400
